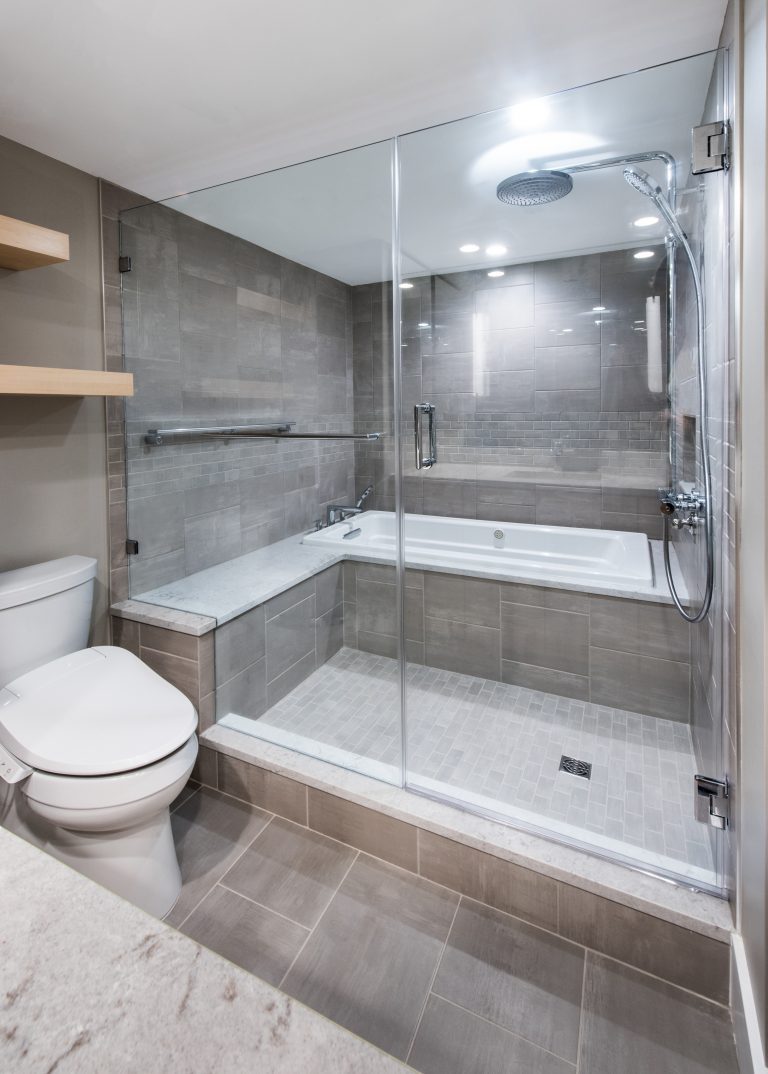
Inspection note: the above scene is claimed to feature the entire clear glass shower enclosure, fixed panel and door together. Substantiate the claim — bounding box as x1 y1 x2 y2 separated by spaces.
115 46 734 890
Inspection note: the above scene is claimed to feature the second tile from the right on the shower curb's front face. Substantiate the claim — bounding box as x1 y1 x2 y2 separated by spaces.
419 828 557 930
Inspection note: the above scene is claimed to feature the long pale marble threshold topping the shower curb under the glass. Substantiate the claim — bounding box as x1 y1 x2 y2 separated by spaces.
200 723 734 943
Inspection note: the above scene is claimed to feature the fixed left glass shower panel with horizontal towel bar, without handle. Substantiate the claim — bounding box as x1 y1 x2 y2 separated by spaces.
120 143 402 782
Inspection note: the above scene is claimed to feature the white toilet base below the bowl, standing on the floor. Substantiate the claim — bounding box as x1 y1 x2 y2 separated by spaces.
2 795 182 917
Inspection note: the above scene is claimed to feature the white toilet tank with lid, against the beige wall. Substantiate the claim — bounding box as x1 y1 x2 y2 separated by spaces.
0 555 97 687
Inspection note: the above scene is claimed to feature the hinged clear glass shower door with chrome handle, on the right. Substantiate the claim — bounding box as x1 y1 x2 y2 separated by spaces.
399 54 727 889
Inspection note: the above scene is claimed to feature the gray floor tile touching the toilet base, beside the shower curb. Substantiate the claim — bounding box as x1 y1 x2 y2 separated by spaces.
165 787 270 925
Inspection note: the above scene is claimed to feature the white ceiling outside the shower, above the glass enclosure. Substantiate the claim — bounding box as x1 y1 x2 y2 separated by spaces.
0 0 726 198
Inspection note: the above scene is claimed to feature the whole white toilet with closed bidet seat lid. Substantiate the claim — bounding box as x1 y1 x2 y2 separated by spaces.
0 555 198 917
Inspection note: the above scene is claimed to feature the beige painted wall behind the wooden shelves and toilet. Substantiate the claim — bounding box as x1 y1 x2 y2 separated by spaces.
0 137 108 642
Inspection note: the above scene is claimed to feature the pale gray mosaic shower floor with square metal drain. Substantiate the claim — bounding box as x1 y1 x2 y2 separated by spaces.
224 649 715 885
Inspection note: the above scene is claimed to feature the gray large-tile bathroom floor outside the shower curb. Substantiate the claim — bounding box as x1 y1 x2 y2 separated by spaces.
169 788 737 1074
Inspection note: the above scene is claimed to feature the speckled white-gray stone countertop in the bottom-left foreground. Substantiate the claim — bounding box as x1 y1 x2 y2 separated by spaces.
0 828 406 1074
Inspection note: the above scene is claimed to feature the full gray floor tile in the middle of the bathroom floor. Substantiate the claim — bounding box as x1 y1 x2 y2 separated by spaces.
281 856 457 1059
